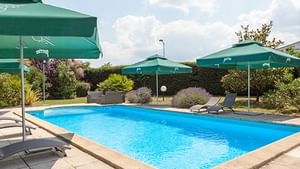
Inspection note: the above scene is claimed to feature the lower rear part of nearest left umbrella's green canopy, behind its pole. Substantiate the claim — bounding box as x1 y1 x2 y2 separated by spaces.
0 32 101 59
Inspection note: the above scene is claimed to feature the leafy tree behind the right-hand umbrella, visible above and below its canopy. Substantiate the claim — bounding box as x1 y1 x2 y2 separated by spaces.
221 21 292 102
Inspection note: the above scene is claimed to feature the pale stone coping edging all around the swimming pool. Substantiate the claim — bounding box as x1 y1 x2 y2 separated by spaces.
15 104 300 169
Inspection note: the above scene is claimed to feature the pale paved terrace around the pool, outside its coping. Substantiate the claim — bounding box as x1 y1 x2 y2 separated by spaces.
0 106 300 169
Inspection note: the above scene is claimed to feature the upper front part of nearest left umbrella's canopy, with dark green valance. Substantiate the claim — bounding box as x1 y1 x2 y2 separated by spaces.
0 0 97 37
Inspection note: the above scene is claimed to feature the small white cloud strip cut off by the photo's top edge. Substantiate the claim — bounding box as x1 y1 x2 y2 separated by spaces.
148 0 216 14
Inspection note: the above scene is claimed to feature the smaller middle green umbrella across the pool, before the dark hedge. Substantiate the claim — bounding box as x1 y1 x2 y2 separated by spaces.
122 54 192 99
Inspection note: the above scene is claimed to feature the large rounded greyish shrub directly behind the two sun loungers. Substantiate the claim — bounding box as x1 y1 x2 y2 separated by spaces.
172 87 211 108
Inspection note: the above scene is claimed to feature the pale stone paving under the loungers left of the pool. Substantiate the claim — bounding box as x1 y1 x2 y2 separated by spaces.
0 110 113 169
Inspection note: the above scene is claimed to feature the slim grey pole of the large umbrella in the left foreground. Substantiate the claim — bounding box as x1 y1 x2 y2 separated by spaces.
20 36 26 141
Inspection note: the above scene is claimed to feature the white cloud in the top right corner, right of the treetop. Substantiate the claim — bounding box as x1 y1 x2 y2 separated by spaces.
238 0 300 44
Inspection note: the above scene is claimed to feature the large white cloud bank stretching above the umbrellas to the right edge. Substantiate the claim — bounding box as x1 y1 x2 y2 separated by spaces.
92 0 300 66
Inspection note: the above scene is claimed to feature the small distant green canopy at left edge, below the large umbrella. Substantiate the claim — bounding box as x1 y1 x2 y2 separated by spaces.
0 59 29 73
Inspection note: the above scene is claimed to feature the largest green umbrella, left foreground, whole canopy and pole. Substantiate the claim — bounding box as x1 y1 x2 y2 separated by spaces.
0 0 100 140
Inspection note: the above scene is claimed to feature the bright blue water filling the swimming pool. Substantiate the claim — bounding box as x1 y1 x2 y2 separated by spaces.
30 105 300 169
